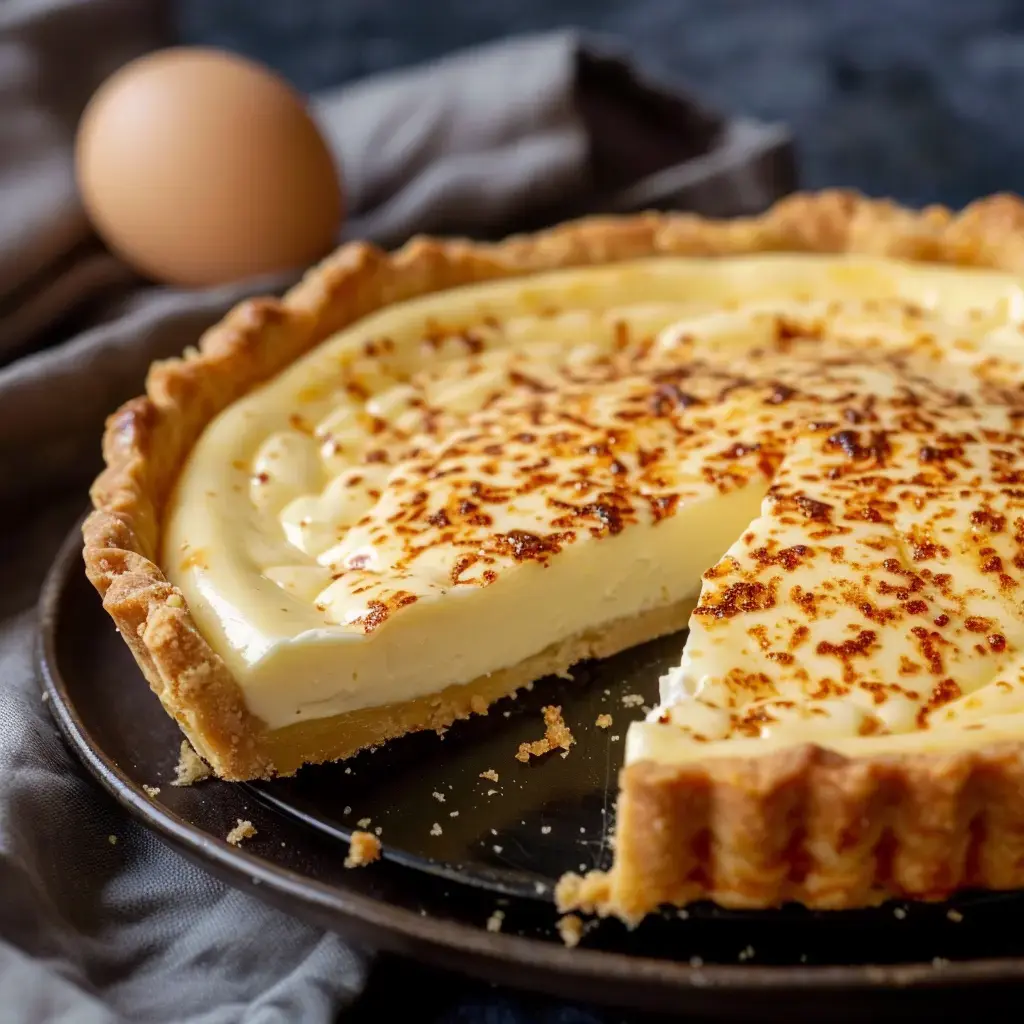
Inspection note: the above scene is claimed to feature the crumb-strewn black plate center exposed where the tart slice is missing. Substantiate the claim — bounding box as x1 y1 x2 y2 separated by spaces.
241 622 682 902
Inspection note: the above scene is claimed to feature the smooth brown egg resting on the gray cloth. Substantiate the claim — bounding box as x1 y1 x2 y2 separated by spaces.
75 47 343 286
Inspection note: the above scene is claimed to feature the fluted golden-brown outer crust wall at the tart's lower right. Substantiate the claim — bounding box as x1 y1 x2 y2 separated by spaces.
556 744 1024 922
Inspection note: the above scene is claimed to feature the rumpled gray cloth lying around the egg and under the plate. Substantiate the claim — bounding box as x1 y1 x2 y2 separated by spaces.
0 0 784 1024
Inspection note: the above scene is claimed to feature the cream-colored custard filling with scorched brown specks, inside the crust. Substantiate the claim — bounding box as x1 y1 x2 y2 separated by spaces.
163 250 1024 760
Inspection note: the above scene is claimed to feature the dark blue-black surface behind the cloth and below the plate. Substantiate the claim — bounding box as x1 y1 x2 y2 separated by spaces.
178 0 1024 1024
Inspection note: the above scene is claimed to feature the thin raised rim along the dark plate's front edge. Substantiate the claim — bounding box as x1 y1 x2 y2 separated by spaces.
34 512 1024 1001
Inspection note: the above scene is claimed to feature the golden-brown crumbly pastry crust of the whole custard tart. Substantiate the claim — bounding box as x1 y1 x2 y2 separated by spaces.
83 190 1024 922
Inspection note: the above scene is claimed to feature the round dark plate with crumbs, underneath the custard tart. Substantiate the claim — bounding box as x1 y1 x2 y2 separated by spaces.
39 516 1024 1020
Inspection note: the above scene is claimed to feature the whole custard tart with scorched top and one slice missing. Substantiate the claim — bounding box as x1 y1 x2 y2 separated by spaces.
84 191 1024 923
